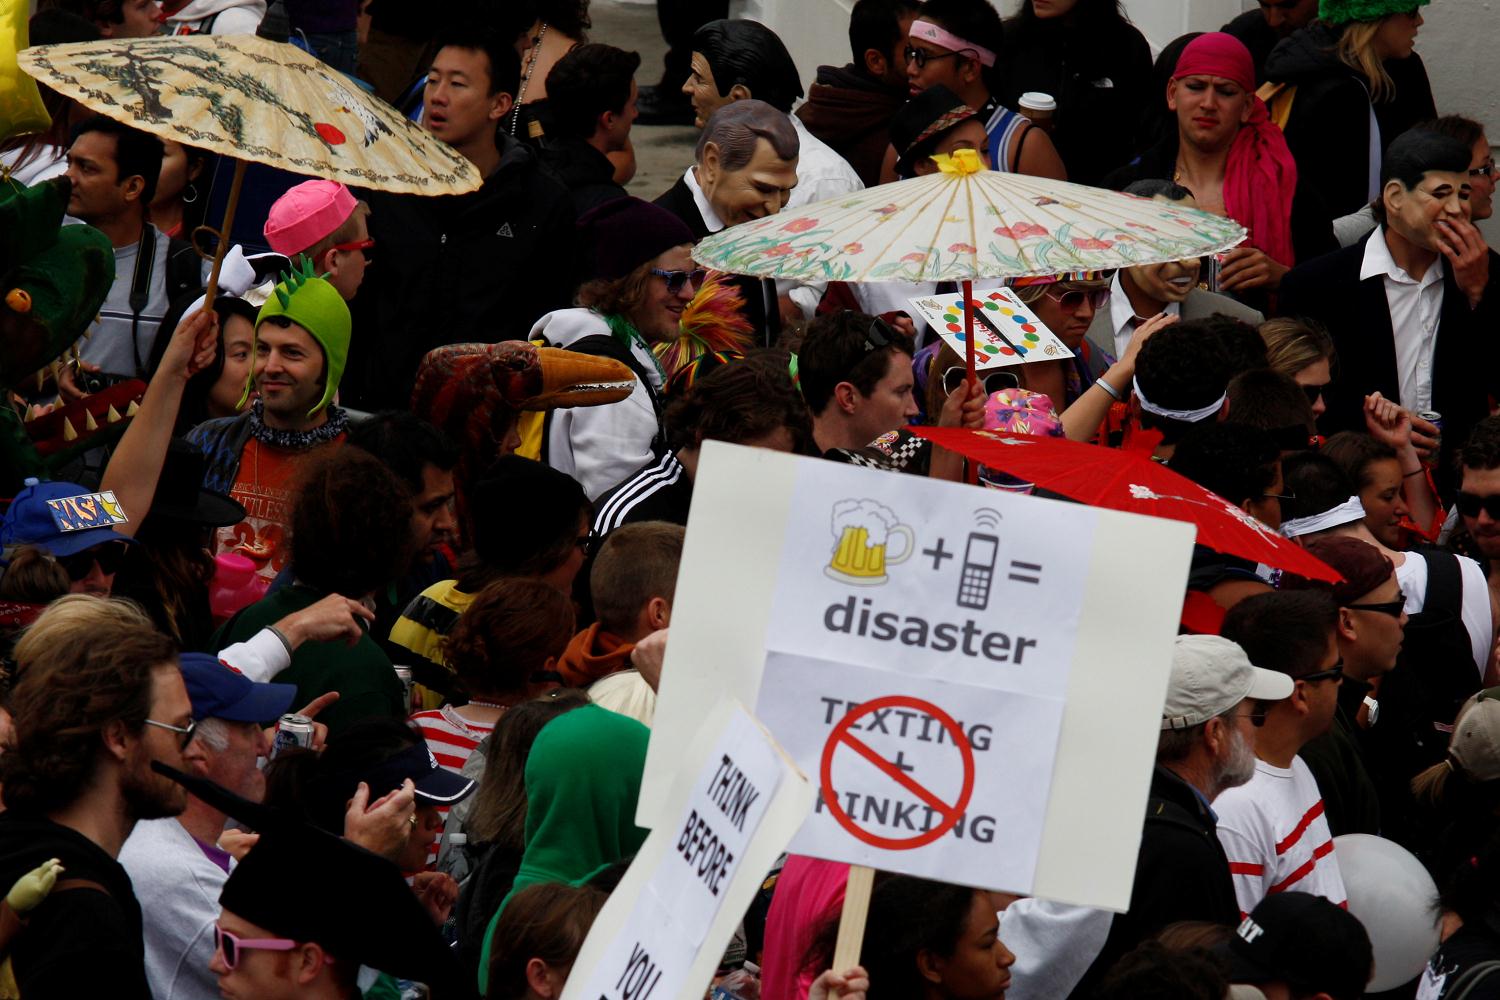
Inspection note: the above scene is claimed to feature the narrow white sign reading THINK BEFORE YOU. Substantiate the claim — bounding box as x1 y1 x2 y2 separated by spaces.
563 700 813 1000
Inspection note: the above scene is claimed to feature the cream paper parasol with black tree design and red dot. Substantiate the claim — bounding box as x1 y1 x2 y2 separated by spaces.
18 34 483 300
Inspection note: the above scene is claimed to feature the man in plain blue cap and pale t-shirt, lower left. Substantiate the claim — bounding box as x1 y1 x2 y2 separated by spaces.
120 652 297 1000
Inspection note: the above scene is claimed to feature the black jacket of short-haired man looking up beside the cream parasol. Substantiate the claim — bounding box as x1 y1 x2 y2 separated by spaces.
344 136 576 409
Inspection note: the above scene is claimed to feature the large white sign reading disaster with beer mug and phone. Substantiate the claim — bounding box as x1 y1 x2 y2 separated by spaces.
636 442 1194 910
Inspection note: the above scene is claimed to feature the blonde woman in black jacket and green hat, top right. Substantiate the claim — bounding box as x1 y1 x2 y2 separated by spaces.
1260 0 1437 219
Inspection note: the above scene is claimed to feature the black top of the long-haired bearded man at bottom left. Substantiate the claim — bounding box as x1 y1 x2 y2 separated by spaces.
0 811 152 1000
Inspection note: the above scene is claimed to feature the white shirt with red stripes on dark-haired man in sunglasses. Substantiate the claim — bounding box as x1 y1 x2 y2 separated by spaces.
1214 757 1349 913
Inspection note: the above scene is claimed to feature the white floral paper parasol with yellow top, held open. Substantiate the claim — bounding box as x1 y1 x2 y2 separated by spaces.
693 150 1245 282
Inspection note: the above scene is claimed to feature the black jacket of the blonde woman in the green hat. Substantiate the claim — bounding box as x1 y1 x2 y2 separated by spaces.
1266 22 1437 219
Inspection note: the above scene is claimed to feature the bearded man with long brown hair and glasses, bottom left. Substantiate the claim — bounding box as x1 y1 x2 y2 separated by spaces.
0 597 194 1000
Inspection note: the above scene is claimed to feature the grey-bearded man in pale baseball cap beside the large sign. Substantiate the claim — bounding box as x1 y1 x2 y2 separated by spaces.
1001 636 1295 1000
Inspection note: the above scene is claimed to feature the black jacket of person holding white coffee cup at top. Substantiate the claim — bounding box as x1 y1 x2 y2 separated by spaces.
996 18 1163 184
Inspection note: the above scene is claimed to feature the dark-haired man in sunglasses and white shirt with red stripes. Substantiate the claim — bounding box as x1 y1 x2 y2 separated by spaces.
1214 591 1347 913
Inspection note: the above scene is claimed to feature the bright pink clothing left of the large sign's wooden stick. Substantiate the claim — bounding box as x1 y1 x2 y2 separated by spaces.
761 855 849 1000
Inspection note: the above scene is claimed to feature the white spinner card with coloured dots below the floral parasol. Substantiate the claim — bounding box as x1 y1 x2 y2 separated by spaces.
908 288 1073 370
